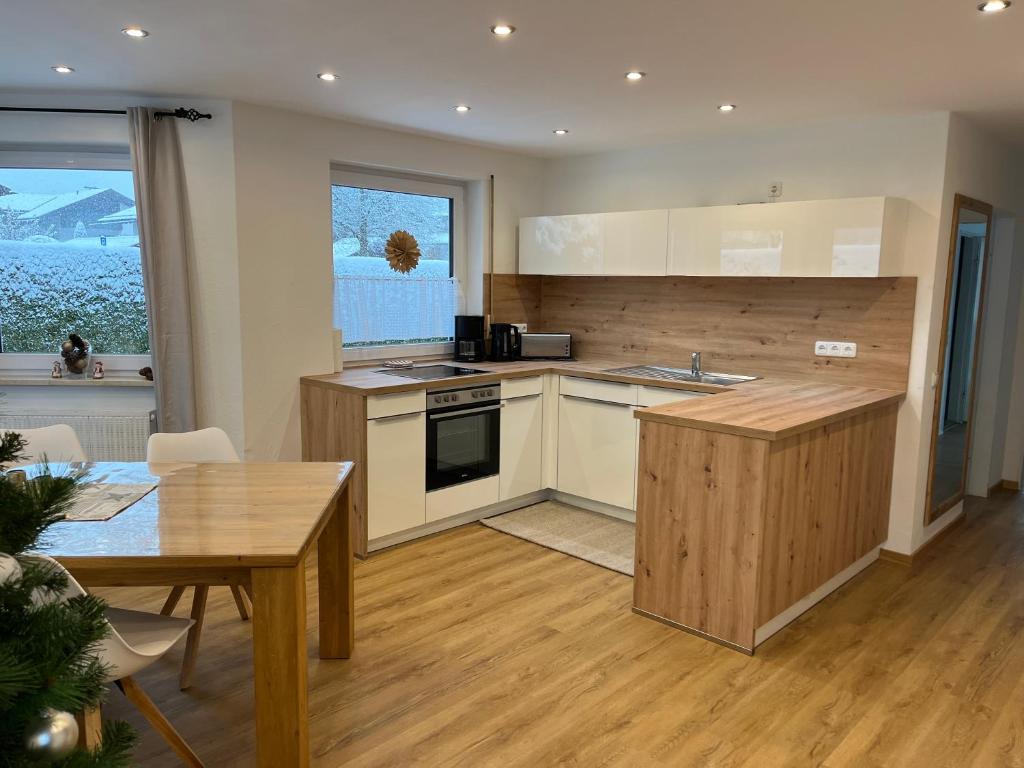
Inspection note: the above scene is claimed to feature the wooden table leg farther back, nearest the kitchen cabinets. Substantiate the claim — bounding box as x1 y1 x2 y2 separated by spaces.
316 485 355 658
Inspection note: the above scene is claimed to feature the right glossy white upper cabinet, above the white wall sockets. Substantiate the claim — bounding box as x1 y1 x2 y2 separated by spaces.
668 198 907 278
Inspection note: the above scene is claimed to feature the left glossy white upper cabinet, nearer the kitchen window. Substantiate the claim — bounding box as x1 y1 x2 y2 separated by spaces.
519 210 669 275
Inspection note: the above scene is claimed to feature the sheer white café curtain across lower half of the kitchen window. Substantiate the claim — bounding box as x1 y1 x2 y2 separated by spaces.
334 274 459 345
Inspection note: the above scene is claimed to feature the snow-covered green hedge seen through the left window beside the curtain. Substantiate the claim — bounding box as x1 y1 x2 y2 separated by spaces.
0 238 150 354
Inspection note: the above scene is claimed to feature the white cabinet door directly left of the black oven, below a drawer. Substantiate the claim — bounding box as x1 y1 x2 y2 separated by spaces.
367 414 427 540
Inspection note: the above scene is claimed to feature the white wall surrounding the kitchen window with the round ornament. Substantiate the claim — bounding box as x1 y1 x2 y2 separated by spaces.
232 102 542 460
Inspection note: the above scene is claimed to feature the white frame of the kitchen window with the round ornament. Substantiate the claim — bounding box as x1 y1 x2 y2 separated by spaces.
331 166 469 361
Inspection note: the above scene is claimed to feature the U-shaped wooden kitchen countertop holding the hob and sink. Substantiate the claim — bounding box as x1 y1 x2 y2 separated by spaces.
302 359 905 440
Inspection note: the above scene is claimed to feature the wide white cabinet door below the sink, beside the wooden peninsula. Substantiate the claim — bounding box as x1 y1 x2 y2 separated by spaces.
558 395 637 509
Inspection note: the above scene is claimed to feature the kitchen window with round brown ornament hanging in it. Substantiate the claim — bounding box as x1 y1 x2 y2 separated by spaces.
331 171 465 357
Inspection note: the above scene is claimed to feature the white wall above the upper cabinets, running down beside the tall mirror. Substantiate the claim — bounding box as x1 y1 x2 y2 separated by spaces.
544 113 1024 553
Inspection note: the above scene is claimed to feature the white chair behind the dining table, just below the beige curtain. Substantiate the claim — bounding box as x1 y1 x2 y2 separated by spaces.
145 427 252 690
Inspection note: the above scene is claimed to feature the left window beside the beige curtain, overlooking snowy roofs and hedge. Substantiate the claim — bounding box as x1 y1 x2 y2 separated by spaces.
0 153 150 355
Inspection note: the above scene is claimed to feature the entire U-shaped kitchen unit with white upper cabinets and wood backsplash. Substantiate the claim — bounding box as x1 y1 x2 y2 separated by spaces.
302 199 915 653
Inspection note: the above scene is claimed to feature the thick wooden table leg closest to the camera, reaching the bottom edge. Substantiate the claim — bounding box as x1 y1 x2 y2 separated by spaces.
252 563 309 768
